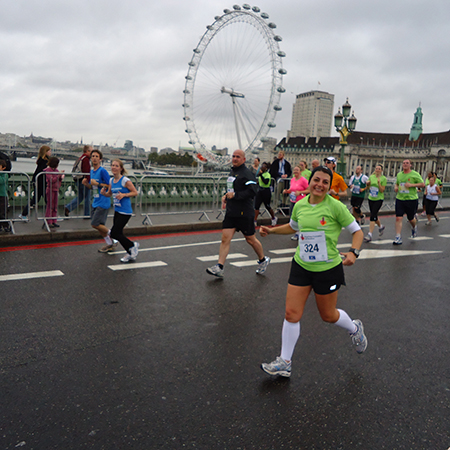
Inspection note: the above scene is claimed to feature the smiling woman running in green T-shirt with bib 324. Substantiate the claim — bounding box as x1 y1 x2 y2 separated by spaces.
259 167 367 377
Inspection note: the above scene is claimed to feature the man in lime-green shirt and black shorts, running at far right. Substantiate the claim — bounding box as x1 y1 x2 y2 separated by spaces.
393 159 425 245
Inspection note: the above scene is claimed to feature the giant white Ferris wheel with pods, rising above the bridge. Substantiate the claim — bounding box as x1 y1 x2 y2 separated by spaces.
183 4 286 165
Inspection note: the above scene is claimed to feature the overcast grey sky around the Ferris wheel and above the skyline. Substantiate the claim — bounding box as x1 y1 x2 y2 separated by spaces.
0 0 450 149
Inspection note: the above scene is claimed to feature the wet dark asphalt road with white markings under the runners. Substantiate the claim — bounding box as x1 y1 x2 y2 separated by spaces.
0 213 450 450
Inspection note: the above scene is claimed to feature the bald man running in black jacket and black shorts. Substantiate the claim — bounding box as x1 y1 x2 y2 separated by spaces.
206 150 270 278
